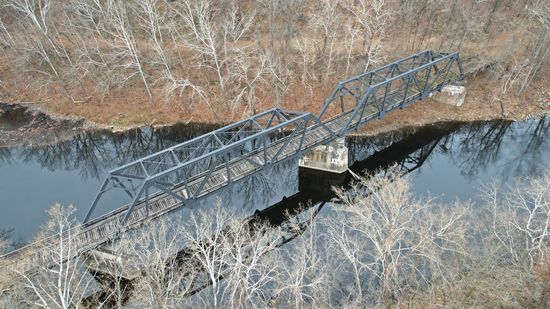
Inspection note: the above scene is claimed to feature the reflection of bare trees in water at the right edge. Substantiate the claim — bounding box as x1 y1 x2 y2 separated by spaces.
448 116 550 178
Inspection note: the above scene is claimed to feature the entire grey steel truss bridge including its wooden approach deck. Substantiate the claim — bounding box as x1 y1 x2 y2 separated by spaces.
0 50 464 275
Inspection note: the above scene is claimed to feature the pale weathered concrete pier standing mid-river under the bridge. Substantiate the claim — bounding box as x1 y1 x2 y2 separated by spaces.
298 138 348 174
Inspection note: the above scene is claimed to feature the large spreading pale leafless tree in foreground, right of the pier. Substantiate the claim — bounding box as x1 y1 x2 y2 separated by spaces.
330 174 467 303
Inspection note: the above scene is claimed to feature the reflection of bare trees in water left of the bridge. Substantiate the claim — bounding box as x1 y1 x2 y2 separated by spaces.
0 124 218 178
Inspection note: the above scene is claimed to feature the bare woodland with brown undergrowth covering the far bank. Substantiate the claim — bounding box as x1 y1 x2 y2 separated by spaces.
0 0 550 121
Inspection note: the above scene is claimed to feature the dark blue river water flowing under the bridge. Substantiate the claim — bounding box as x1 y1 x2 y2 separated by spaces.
0 116 550 242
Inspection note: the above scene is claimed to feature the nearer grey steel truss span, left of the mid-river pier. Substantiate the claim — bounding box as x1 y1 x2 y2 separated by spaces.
84 109 335 224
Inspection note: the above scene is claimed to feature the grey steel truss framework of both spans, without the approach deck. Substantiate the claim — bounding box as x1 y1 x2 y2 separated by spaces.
84 50 464 224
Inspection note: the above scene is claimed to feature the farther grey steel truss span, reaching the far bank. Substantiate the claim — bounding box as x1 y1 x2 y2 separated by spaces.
319 50 464 136
